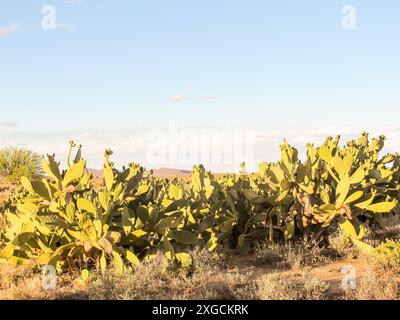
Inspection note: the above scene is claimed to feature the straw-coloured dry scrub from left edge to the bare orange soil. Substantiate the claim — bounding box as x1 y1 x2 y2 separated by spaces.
0 250 249 300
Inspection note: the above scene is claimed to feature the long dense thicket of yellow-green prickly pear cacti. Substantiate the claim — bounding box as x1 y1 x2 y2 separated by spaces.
0 133 400 272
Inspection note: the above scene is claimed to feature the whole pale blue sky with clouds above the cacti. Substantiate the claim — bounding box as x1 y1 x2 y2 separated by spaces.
0 0 400 170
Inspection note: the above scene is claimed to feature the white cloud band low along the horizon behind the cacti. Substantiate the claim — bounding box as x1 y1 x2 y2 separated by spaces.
0 126 400 172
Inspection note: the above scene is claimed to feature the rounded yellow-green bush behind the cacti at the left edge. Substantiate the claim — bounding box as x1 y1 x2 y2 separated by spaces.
0 148 42 183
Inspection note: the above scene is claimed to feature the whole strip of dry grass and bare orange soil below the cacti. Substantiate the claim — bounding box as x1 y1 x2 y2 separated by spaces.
0 212 400 300
